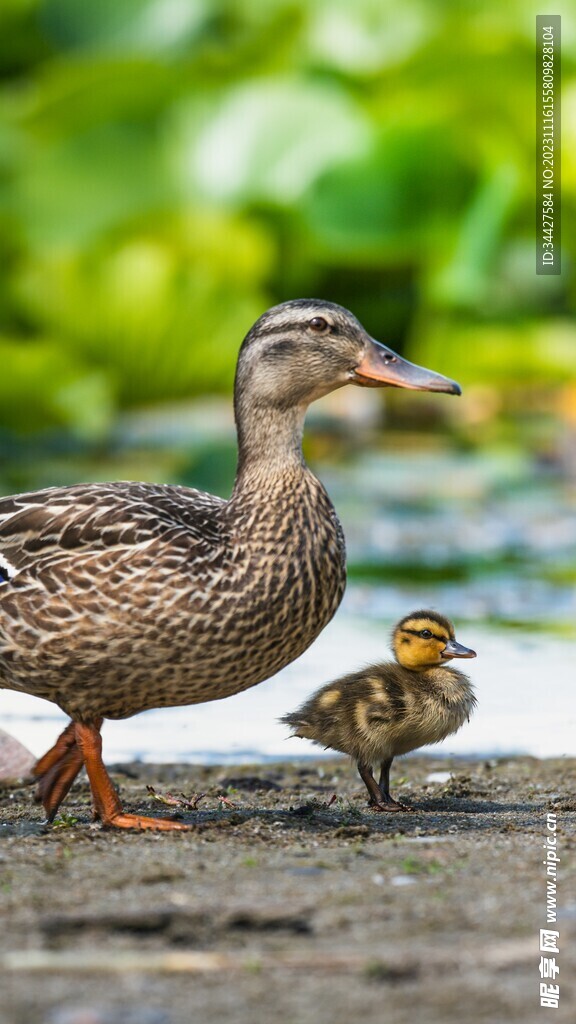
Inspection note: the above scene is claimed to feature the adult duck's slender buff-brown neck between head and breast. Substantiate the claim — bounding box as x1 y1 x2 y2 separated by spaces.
233 406 306 497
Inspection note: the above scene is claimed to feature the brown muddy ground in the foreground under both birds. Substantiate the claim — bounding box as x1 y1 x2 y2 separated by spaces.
0 757 576 1024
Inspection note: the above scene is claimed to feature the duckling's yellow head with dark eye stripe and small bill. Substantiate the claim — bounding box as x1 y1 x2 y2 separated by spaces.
393 610 476 672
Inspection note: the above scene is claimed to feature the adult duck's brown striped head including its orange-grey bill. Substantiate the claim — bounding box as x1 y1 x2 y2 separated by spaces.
236 299 460 410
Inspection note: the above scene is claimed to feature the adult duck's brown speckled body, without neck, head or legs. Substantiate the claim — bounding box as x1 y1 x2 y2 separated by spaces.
0 471 345 721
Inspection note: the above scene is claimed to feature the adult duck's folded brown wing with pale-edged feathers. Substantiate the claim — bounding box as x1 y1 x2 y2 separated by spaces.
0 482 225 583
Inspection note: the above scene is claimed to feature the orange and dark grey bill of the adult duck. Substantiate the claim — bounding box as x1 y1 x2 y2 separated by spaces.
352 338 462 394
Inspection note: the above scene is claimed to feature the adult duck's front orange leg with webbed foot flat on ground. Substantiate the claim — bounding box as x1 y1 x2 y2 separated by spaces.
74 722 191 831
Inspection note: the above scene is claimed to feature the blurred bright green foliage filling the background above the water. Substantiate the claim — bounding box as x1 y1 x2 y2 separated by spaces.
0 0 576 456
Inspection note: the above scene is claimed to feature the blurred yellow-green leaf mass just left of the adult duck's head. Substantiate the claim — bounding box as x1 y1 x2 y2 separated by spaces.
11 214 273 403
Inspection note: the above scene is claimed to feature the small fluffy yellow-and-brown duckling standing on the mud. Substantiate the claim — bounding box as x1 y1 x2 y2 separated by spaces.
281 610 477 811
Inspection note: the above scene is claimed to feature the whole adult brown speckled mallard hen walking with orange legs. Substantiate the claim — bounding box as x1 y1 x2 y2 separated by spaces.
0 299 459 829
